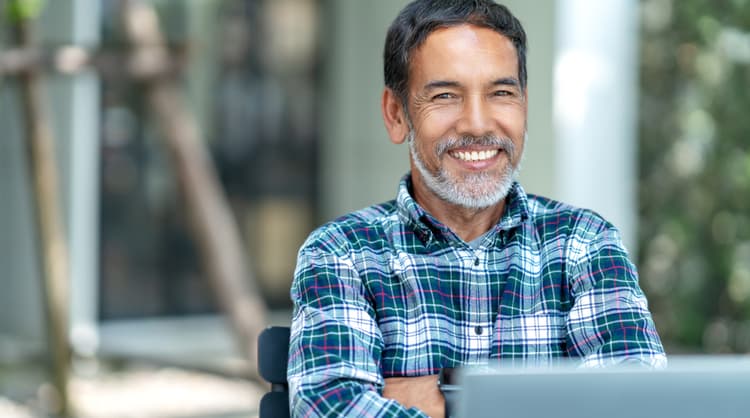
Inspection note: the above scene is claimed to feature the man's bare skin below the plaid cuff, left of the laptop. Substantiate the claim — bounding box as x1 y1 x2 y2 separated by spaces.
383 375 445 418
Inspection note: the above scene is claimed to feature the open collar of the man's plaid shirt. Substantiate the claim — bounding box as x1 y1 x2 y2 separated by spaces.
396 173 529 245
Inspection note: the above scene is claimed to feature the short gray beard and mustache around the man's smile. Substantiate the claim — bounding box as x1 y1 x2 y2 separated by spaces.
407 128 525 209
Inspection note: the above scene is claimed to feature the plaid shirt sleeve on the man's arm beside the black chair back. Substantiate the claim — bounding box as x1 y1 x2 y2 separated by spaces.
287 233 426 417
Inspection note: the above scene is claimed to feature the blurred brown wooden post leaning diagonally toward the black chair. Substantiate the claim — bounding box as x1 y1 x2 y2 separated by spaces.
121 0 274 379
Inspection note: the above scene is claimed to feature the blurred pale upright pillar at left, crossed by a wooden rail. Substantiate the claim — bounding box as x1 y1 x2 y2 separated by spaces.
40 0 101 355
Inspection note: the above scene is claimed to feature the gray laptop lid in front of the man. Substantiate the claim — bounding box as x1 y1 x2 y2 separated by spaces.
451 356 750 418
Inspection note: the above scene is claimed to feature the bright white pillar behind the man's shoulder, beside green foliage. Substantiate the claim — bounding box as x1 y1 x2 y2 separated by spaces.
554 0 638 253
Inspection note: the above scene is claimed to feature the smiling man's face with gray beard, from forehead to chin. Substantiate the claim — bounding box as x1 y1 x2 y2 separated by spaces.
407 25 527 208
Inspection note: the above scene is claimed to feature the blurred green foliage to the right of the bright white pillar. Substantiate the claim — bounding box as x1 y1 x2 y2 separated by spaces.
639 0 750 352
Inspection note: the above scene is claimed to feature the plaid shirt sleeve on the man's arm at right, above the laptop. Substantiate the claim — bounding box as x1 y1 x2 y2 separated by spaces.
566 224 666 367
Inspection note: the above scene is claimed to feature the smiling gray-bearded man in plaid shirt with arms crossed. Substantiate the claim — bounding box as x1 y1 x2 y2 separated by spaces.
288 0 665 417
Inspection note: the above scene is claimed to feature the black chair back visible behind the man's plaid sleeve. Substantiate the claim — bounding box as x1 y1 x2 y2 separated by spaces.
258 327 290 418
